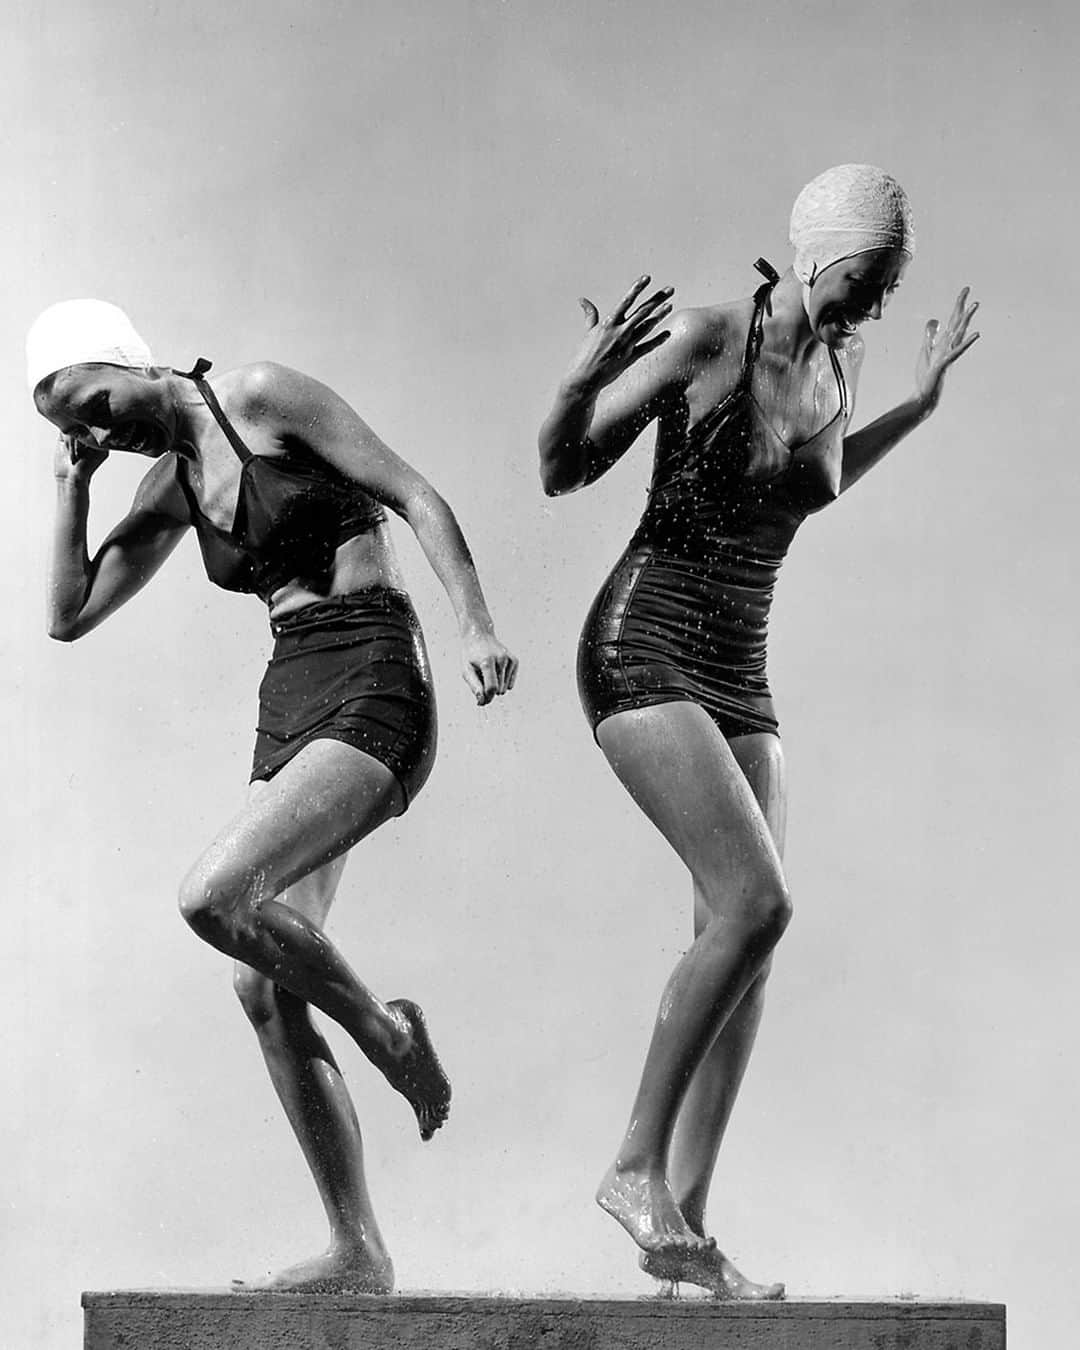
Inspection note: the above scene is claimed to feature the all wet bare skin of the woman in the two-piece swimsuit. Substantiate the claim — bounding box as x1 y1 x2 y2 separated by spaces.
35 363 517 1293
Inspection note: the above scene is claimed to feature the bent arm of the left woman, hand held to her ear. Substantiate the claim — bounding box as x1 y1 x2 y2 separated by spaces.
49 436 189 643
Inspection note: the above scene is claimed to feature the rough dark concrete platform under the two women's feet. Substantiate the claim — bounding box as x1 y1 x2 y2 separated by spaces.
82 1291 1004 1350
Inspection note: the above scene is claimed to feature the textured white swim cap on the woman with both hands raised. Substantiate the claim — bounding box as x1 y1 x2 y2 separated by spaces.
788 165 915 286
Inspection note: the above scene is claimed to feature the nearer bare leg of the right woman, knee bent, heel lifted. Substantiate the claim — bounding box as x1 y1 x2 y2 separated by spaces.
597 702 790 1258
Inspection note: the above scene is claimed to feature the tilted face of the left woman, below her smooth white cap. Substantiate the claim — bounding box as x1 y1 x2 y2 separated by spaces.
34 365 174 458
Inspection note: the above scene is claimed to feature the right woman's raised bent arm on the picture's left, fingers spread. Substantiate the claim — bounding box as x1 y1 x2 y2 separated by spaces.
539 277 679 497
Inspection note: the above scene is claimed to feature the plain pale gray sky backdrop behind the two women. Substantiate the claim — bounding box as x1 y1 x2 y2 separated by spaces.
0 0 1080 1350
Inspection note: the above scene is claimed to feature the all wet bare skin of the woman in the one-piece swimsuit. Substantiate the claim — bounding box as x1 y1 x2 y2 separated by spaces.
540 250 979 1299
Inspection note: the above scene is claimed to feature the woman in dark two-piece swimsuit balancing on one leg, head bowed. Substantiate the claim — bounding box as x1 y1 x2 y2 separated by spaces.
27 300 517 1293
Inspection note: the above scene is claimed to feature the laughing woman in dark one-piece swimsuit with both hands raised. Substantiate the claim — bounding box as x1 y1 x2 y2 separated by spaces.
540 165 977 1299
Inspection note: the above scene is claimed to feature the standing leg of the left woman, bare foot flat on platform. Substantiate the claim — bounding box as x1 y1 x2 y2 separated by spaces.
234 831 394 1293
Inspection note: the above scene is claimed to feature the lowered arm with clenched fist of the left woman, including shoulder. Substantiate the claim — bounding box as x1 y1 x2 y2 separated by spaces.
244 362 517 705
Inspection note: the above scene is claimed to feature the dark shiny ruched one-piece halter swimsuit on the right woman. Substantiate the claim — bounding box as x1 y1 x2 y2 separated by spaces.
578 269 848 738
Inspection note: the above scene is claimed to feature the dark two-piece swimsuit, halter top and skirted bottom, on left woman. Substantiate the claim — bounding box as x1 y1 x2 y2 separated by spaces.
176 359 436 805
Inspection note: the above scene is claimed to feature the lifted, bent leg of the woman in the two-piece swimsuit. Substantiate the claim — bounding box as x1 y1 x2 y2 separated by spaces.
180 740 450 1138
